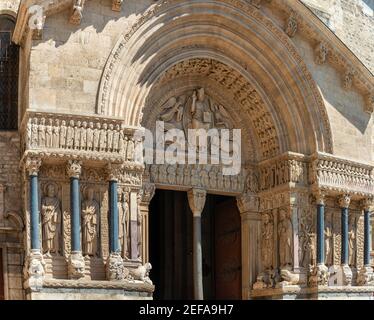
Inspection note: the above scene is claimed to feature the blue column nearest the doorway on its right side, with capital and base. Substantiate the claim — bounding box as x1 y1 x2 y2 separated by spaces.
309 192 330 287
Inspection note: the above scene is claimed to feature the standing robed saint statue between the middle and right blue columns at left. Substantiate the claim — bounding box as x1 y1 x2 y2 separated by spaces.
82 187 99 256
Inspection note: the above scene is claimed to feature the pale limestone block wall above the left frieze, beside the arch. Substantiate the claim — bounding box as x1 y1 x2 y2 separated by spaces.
30 0 153 113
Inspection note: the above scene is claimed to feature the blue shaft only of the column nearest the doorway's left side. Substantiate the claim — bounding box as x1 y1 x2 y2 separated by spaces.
109 180 120 253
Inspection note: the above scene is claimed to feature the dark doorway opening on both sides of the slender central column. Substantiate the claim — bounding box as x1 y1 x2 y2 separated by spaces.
149 190 241 300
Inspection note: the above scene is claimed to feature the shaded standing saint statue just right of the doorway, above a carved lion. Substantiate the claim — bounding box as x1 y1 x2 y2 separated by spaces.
278 209 292 269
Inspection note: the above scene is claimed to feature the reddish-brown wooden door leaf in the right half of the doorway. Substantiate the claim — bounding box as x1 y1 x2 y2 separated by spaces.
214 198 242 300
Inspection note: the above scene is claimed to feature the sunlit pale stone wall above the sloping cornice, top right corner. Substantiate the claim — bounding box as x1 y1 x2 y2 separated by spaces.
302 0 374 73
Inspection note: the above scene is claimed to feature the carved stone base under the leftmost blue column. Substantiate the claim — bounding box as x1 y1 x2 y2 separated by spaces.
23 250 45 290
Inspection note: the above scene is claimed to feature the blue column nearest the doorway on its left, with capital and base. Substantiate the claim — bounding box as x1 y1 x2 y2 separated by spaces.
106 164 129 280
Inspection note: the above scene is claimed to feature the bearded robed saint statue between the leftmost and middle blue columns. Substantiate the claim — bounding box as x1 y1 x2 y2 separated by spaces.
41 183 61 256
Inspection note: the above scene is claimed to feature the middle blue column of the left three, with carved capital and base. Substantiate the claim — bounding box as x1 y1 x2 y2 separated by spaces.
66 160 85 279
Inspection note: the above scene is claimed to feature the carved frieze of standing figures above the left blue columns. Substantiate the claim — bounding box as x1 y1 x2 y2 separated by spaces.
21 112 141 162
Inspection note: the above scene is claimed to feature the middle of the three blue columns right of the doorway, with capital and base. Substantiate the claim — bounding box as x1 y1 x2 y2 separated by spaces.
339 194 352 285
